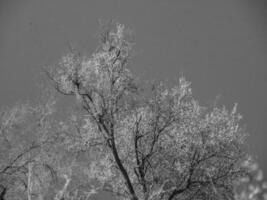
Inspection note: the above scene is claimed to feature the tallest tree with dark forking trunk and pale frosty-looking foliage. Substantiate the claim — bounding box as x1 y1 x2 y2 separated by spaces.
47 24 251 200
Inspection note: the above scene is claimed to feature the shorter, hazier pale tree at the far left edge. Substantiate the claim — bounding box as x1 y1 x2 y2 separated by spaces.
0 95 58 200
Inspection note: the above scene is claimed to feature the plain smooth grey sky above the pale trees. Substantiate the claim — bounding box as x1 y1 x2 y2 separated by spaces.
0 0 267 177
